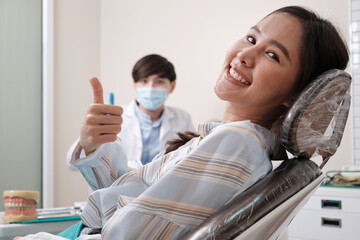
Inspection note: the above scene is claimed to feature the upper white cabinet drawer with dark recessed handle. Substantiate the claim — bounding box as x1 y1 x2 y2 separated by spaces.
304 196 360 214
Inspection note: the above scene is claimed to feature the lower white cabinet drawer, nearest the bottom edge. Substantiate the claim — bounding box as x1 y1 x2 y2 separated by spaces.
288 209 360 240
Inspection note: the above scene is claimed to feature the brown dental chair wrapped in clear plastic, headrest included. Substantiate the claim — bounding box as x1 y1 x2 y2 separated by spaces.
185 69 351 240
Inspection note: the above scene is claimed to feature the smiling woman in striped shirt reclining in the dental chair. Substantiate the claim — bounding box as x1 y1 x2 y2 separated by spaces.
17 4 349 239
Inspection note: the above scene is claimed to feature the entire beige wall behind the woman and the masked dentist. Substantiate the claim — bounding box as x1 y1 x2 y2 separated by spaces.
55 0 352 206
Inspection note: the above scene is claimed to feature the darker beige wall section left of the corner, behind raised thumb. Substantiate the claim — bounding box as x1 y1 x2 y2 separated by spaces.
54 0 100 206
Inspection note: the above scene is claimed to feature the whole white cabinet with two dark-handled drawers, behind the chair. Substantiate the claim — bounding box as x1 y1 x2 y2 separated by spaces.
288 186 360 240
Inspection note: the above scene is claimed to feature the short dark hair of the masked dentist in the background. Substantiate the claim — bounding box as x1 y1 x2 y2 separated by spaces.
132 54 176 82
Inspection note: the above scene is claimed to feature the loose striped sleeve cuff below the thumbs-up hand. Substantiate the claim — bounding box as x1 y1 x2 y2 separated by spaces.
69 141 127 190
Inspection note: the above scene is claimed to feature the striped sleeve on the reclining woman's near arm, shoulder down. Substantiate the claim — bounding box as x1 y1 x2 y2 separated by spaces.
90 126 271 239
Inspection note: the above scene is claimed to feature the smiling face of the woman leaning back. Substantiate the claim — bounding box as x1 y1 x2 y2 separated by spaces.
215 13 302 123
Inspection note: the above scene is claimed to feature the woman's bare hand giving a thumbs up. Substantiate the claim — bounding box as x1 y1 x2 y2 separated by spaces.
80 77 123 155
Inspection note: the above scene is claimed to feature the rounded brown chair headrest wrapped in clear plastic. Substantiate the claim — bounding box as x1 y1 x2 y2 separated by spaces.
280 69 351 158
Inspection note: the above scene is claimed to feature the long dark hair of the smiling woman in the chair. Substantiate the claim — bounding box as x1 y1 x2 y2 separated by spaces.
166 6 349 152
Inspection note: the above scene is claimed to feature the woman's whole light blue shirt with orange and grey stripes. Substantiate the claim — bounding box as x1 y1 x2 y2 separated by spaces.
22 121 279 240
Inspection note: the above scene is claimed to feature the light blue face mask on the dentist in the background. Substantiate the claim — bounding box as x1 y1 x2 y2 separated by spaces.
136 88 168 111
